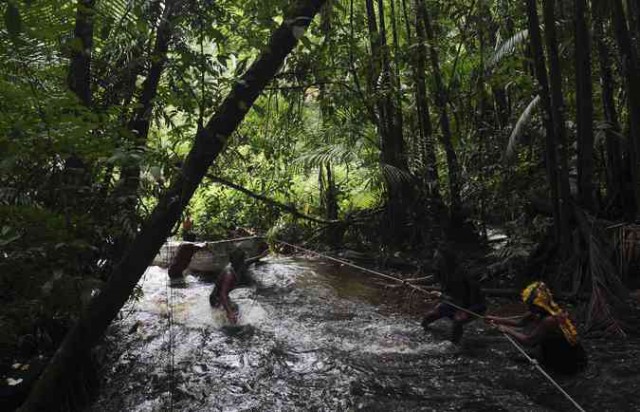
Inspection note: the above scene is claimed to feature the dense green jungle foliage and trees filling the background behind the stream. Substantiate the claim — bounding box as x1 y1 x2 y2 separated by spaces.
0 0 640 406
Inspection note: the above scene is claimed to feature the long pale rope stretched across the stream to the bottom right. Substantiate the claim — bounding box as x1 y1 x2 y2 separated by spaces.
275 239 585 412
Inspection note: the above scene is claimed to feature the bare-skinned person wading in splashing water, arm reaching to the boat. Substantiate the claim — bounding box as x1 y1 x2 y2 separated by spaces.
209 248 269 324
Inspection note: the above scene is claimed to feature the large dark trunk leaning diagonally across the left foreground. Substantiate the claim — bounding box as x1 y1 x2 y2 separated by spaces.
20 0 323 412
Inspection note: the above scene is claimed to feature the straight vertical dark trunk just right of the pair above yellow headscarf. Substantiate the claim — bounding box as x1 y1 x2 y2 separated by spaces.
574 0 595 210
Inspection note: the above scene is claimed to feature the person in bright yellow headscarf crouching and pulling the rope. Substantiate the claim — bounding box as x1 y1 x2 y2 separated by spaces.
485 282 587 374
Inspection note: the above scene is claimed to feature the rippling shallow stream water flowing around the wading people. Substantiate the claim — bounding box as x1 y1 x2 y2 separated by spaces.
91 257 640 412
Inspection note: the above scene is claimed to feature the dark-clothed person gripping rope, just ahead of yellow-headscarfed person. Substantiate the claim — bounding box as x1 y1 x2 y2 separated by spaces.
422 247 487 343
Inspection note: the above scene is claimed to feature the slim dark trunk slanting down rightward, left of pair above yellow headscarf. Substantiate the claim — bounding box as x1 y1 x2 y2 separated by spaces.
527 0 561 242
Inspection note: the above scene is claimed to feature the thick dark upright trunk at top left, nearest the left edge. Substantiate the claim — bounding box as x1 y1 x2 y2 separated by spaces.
68 0 95 107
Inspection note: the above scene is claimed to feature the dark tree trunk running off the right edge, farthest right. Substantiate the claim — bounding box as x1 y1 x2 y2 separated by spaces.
610 0 640 219
